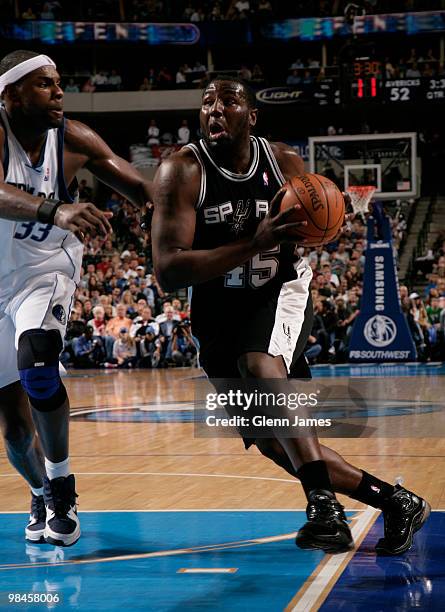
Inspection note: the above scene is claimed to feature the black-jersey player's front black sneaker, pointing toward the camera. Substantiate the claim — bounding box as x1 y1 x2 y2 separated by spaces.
296 489 354 553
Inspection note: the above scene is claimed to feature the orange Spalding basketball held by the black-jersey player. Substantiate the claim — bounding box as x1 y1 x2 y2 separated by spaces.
280 174 345 247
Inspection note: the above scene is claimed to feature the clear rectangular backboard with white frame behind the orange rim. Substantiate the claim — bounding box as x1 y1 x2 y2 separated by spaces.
309 132 418 199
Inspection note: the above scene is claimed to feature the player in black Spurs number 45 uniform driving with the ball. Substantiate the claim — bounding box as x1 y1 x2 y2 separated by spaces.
152 77 429 554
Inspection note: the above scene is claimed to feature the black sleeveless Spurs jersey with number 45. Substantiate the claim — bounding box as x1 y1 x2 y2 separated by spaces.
187 136 297 325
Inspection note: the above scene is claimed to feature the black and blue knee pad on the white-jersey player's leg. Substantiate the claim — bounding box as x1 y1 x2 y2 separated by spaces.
17 329 67 412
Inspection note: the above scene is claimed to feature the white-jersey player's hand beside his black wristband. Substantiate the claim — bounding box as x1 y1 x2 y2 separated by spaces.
54 202 113 242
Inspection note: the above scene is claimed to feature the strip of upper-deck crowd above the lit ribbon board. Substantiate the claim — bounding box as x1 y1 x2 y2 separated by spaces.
9 0 443 22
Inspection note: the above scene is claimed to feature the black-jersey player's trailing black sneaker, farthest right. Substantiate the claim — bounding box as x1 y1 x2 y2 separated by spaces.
375 485 431 555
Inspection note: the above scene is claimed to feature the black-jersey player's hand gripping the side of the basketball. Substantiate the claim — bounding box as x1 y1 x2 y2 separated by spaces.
253 188 307 253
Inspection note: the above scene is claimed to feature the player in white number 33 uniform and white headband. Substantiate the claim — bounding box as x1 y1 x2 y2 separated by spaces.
0 51 151 546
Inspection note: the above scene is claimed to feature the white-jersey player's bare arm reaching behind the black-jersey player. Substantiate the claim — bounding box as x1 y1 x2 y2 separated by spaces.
65 120 152 208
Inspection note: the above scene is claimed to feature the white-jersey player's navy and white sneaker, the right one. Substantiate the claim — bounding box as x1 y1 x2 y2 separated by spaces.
43 474 80 546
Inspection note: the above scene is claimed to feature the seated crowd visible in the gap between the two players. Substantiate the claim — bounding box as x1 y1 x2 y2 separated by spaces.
62 188 197 368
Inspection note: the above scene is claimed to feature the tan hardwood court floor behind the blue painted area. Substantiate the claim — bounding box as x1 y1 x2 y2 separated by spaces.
0 366 445 512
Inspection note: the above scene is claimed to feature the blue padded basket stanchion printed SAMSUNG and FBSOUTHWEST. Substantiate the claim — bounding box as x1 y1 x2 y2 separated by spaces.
349 204 416 362
